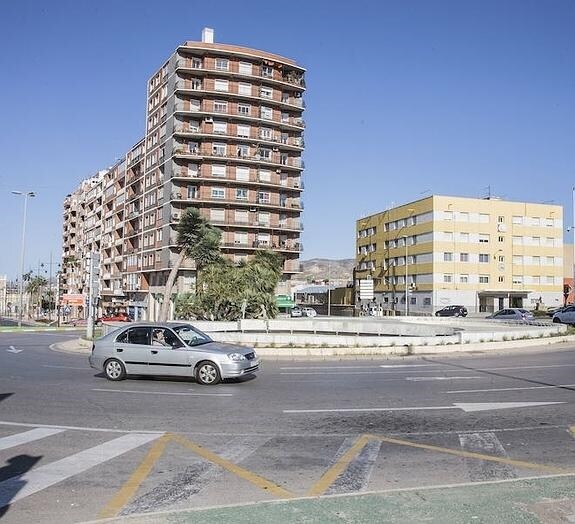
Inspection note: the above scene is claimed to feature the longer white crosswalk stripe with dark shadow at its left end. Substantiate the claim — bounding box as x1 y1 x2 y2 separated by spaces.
0 433 161 508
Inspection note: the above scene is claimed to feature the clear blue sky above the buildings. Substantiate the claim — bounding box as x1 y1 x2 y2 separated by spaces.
0 0 575 277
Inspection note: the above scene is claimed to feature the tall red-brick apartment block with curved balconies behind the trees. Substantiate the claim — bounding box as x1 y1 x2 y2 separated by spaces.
59 29 305 318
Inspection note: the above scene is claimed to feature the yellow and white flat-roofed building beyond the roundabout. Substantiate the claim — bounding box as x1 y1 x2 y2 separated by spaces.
356 195 563 313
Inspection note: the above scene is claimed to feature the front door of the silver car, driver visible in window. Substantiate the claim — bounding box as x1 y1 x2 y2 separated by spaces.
148 328 192 376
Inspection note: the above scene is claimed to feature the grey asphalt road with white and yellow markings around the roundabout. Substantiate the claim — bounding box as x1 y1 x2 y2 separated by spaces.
0 333 575 523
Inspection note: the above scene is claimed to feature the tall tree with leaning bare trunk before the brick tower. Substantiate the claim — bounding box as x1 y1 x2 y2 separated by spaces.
159 207 222 322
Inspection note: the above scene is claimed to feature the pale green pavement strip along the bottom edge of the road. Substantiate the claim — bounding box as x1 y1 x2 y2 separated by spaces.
85 475 575 524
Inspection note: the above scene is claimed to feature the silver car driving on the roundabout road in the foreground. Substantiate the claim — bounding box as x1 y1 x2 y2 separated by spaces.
89 322 260 385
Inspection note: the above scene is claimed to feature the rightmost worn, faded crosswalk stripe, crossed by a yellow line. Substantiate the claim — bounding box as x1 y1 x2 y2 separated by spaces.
459 432 517 481
